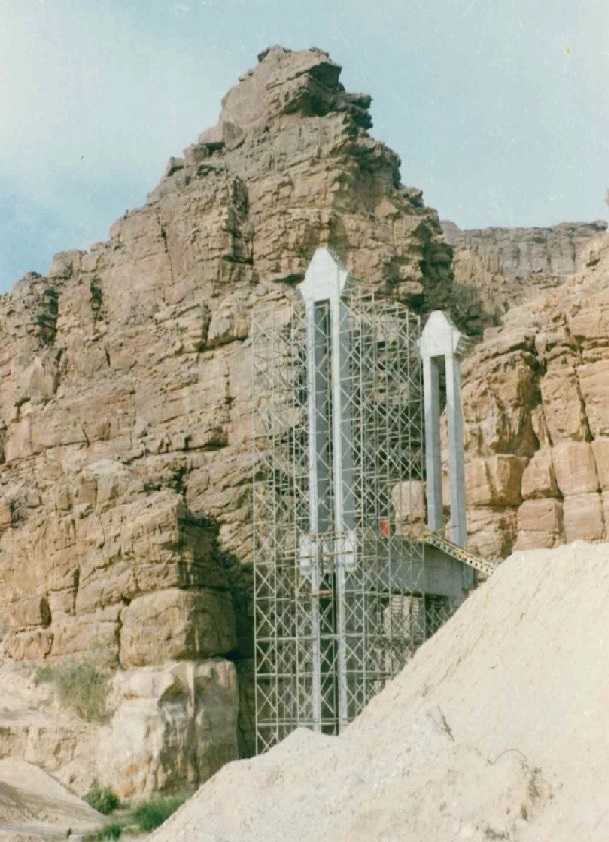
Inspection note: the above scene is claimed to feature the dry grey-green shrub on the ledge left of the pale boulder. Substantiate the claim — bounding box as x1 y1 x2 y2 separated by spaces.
34 660 110 722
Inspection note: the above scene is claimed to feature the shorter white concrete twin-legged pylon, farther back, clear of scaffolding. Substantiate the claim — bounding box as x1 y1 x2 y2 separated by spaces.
419 310 467 547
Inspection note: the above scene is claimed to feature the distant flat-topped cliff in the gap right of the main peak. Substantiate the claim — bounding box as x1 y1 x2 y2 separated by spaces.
441 220 607 333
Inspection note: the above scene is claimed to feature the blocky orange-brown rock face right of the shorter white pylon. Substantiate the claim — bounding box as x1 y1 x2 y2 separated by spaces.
463 235 609 557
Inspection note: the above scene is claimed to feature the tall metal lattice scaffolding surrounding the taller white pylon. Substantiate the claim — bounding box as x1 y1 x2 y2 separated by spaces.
253 268 459 752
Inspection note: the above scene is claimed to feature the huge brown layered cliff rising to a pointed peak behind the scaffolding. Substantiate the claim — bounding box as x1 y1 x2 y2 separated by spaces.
0 47 451 794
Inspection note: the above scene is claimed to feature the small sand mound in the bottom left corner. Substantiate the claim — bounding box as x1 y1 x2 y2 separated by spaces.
0 759 104 839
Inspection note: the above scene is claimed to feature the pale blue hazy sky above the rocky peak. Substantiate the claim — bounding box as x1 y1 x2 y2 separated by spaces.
0 0 609 292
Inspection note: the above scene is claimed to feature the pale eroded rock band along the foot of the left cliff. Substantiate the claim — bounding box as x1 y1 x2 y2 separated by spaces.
0 658 239 799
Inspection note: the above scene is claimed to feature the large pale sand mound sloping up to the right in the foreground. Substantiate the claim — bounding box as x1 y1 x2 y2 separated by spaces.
152 543 609 842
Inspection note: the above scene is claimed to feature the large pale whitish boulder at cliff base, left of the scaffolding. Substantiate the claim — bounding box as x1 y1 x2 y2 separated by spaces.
96 659 239 799
